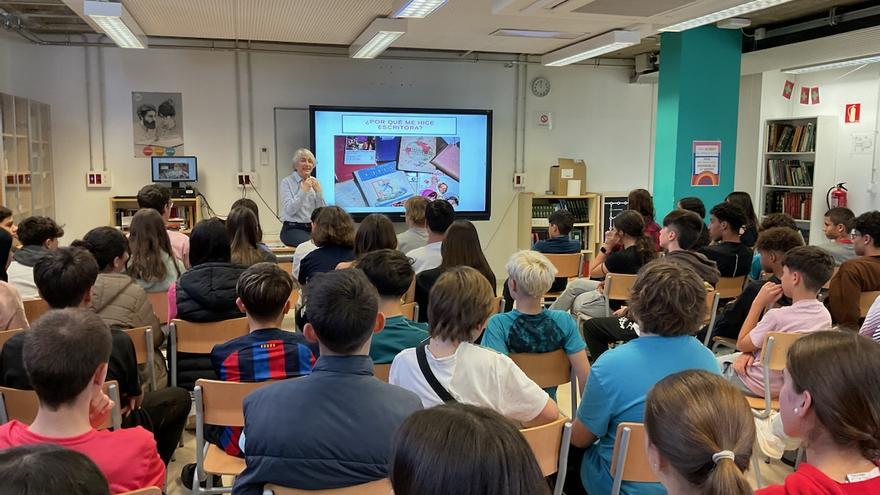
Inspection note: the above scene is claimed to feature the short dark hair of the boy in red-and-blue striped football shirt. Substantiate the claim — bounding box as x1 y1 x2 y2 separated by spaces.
235 262 294 320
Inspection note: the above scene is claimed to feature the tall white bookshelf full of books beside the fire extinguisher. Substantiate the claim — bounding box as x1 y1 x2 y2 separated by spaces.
756 116 837 244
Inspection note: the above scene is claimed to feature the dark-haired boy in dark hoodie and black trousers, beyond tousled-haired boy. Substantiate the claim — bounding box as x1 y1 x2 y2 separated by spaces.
584 210 719 361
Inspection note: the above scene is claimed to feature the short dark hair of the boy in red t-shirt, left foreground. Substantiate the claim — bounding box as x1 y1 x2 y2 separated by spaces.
22 308 112 411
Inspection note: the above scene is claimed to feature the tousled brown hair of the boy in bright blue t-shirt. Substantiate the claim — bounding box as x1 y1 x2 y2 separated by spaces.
629 259 706 337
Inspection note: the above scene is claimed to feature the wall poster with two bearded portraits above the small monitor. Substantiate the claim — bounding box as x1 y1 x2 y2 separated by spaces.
131 91 184 158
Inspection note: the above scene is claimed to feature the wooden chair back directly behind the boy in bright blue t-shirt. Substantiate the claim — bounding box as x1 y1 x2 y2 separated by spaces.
611 423 659 495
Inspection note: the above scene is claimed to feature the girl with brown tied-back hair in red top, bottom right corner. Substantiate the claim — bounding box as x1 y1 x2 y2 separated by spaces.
757 332 880 495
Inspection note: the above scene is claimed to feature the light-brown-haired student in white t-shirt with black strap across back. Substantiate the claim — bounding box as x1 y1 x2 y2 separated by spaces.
389 266 559 426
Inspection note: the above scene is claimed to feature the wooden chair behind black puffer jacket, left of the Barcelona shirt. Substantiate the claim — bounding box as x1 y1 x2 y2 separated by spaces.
168 318 248 387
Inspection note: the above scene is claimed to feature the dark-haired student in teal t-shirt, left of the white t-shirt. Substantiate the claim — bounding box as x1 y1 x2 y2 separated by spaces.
355 249 428 364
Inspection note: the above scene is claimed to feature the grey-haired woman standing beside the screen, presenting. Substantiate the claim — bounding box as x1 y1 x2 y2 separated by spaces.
278 148 327 247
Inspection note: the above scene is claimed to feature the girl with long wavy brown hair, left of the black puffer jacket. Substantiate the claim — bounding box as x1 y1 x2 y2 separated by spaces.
125 209 186 294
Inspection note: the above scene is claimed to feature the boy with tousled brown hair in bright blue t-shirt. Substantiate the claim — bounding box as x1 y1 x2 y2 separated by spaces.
566 260 720 495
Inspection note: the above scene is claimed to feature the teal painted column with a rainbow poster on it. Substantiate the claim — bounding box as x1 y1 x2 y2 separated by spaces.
654 26 742 222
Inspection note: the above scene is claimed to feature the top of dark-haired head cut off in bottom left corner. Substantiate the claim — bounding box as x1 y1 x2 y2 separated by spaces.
0 443 110 495
